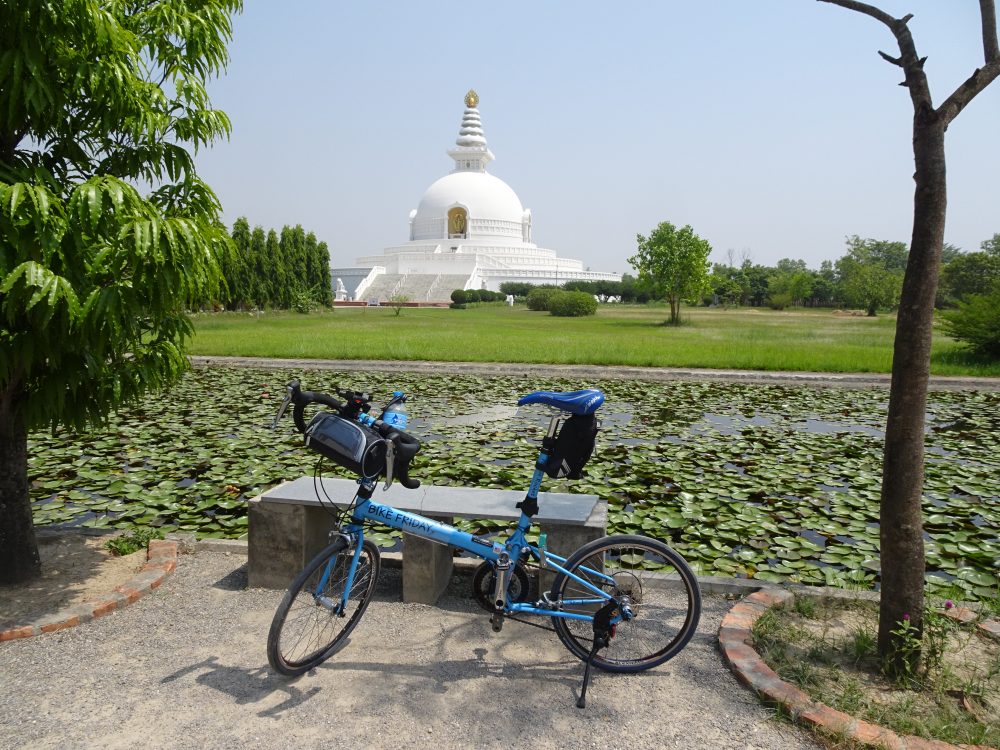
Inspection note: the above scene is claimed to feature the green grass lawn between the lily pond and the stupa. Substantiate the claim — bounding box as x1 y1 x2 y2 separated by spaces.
191 305 1000 376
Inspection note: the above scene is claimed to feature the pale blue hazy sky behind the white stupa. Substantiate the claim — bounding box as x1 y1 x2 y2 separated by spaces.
198 0 1000 272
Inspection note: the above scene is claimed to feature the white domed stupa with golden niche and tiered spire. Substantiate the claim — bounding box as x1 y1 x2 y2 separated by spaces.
331 91 621 302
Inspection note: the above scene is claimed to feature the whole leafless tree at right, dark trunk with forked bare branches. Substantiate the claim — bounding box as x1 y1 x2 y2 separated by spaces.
820 0 1000 674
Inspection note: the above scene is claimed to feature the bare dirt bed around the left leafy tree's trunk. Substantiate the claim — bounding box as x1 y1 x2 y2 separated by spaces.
0 534 146 630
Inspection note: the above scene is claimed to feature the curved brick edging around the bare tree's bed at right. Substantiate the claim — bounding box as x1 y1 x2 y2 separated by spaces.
719 588 1000 750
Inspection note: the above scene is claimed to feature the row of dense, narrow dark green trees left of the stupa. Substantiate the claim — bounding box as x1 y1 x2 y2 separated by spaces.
218 217 333 312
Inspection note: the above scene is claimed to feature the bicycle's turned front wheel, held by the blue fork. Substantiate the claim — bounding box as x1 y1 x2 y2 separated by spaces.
267 537 381 675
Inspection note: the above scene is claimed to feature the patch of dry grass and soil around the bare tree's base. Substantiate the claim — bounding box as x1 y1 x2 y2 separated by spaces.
752 597 1000 747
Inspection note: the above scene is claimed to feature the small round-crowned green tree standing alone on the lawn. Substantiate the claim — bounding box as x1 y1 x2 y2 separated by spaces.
628 221 712 325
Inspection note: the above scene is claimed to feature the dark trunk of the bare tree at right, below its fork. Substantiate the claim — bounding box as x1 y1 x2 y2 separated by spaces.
878 114 947 674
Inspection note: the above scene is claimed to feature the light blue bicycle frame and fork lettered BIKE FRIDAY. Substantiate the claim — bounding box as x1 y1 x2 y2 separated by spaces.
316 428 623 624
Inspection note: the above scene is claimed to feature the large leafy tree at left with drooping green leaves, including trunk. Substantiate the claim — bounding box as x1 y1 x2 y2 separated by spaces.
0 0 241 582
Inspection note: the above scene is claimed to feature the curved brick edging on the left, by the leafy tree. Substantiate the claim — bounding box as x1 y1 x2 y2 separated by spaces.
0 539 177 641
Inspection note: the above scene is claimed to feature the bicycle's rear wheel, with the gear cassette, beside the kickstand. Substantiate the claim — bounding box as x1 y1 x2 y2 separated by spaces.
550 534 701 672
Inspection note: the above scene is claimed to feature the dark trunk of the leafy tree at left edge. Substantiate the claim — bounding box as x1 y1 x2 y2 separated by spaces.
0 383 42 583
